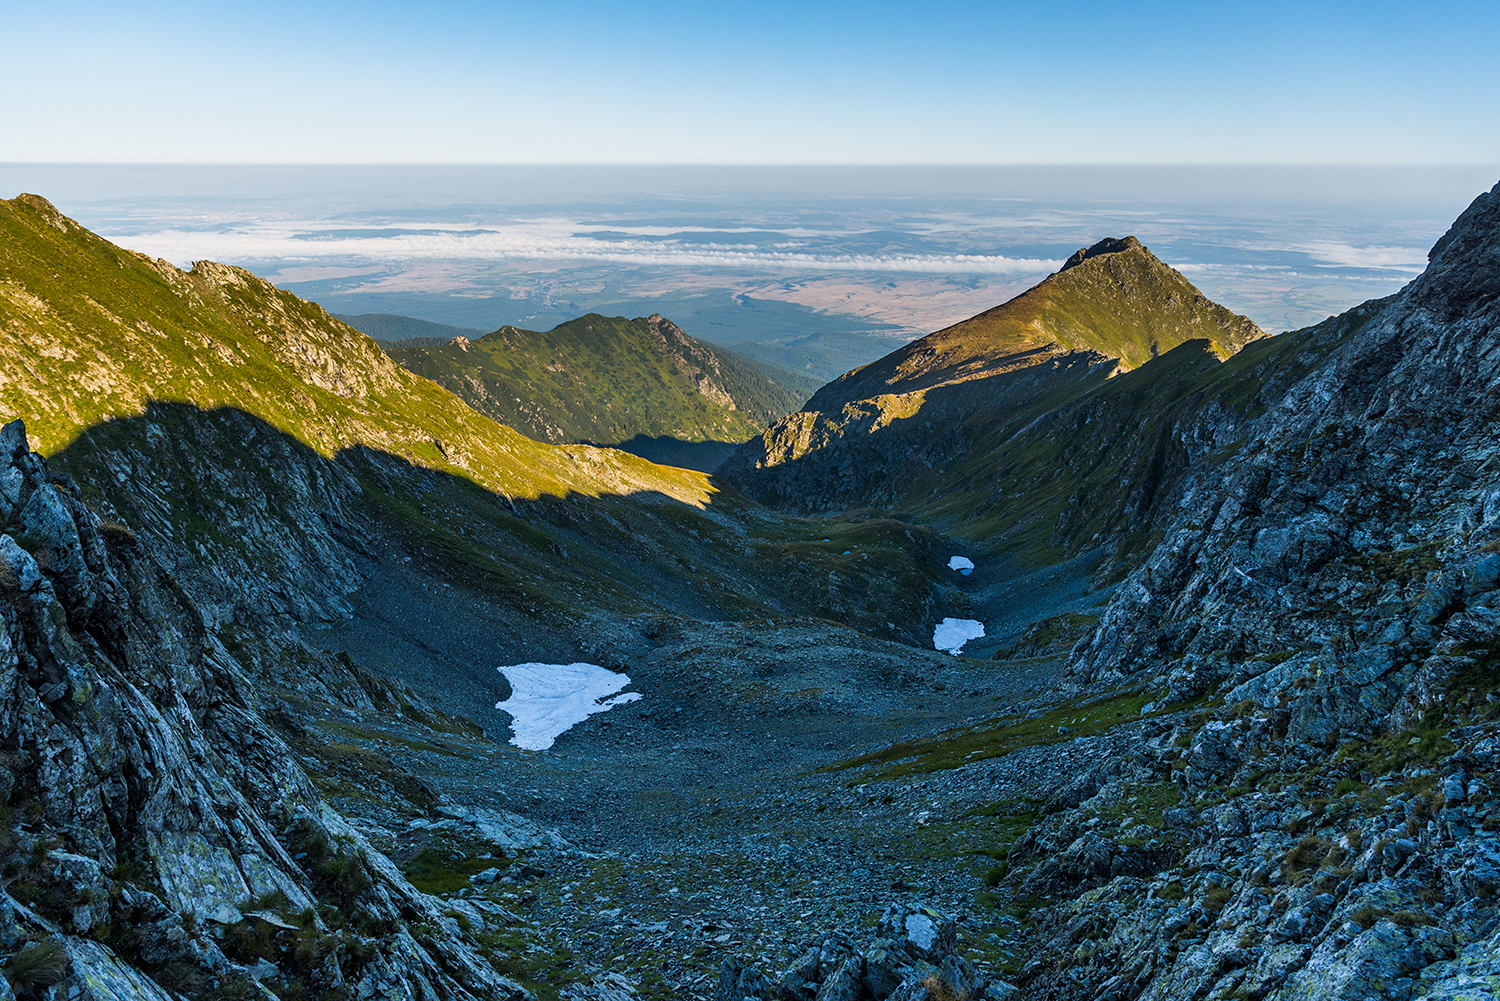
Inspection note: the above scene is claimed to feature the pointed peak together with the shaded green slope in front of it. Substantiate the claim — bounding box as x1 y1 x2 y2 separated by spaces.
716 237 1301 572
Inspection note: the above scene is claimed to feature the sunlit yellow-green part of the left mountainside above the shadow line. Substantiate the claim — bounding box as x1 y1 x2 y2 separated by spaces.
0 195 711 504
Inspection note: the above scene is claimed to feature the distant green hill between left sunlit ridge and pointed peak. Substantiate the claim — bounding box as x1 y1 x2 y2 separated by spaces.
389 314 816 470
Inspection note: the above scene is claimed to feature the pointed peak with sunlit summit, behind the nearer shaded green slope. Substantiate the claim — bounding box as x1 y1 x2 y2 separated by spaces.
716 237 1263 522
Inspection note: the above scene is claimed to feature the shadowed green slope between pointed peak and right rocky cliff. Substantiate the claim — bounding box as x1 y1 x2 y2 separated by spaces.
911 305 1368 578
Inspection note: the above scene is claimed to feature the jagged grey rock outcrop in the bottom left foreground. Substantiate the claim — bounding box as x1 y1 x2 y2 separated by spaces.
0 422 525 1001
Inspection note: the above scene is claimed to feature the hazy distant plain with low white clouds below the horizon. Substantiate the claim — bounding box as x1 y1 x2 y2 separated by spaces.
0 164 1493 378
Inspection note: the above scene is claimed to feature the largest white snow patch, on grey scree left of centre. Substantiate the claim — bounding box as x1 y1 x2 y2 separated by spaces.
495 663 641 750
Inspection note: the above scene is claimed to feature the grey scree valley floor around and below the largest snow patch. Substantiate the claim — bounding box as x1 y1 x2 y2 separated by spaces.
298 543 1161 998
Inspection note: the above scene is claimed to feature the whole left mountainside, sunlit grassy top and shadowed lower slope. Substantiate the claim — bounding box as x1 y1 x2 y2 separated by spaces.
0 195 942 642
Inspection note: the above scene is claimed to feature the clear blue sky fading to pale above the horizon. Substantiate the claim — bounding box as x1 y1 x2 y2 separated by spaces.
0 0 1500 164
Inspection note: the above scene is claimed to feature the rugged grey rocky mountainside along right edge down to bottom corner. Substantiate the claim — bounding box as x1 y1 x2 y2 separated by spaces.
1010 186 1500 1001
